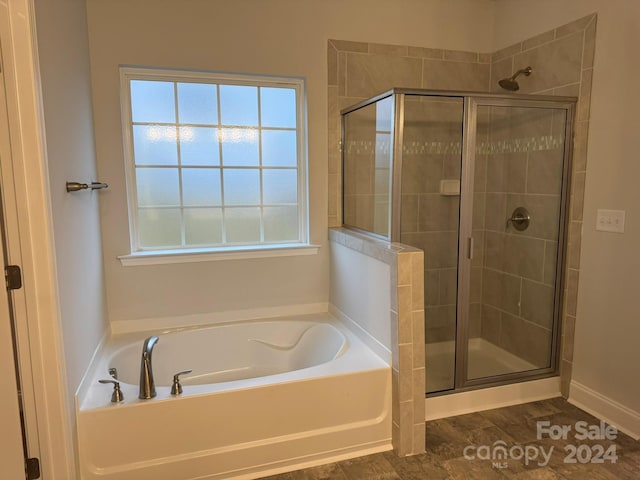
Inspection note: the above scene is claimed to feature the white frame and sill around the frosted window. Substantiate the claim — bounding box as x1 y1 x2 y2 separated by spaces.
118 67 318 266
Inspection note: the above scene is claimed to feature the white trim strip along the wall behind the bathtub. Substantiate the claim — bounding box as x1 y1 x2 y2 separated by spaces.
111 303 329 335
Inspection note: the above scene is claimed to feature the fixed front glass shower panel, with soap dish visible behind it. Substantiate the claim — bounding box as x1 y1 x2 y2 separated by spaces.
400 95 464 393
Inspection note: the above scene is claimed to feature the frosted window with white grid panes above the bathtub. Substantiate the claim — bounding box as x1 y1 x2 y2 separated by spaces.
121 68 307 254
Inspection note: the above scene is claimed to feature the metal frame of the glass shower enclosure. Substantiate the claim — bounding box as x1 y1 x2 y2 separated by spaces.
340 88 577 396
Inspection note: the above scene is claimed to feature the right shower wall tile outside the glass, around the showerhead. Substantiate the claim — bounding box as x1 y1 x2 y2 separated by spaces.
491 14 597 397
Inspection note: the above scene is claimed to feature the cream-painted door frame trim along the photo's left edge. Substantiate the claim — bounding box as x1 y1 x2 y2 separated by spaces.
0 0 76 480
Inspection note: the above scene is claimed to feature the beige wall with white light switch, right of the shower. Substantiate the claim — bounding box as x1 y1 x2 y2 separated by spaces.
494 0 640 415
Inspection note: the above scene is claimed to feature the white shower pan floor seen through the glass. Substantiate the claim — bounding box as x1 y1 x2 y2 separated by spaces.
425 338 536 392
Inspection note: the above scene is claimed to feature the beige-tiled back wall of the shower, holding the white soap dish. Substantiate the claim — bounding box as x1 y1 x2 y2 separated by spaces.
328 40 491 342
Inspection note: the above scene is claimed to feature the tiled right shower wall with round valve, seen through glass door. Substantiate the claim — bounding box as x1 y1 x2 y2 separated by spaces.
480 107 565 368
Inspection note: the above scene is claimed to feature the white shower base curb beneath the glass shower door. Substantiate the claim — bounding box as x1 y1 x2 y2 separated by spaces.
425 377 560 420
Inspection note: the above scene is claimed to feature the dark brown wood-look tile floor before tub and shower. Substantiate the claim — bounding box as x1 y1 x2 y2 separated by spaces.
266 398 640 480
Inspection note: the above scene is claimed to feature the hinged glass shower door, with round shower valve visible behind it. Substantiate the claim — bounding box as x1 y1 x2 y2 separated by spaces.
458 100 570 386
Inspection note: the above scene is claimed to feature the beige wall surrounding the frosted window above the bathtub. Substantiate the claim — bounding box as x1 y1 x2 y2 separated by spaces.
87 0 492 320
